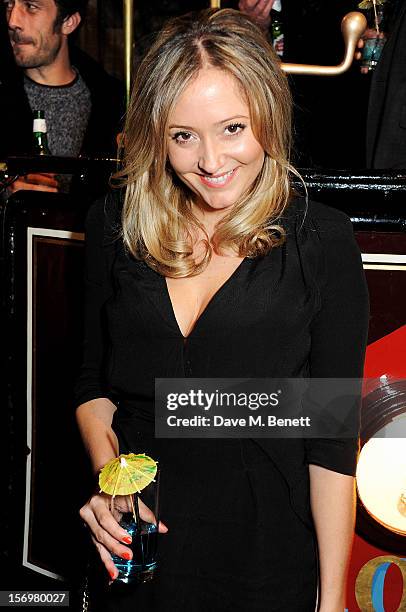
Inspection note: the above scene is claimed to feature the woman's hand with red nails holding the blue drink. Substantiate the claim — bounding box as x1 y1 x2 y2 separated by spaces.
79 493 168 580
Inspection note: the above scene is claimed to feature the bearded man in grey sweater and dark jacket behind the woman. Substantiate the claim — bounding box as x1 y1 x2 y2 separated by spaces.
0 0 124 191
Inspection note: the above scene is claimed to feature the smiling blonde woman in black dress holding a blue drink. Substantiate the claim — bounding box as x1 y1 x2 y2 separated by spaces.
77 10 368 612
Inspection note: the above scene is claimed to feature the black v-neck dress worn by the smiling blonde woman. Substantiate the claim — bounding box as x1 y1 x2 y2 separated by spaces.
76 189 368 612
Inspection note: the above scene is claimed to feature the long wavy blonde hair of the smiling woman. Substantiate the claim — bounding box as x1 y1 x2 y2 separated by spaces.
114 9 297 278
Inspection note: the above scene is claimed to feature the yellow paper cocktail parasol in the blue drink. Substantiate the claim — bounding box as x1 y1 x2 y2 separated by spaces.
99 453 157 497
